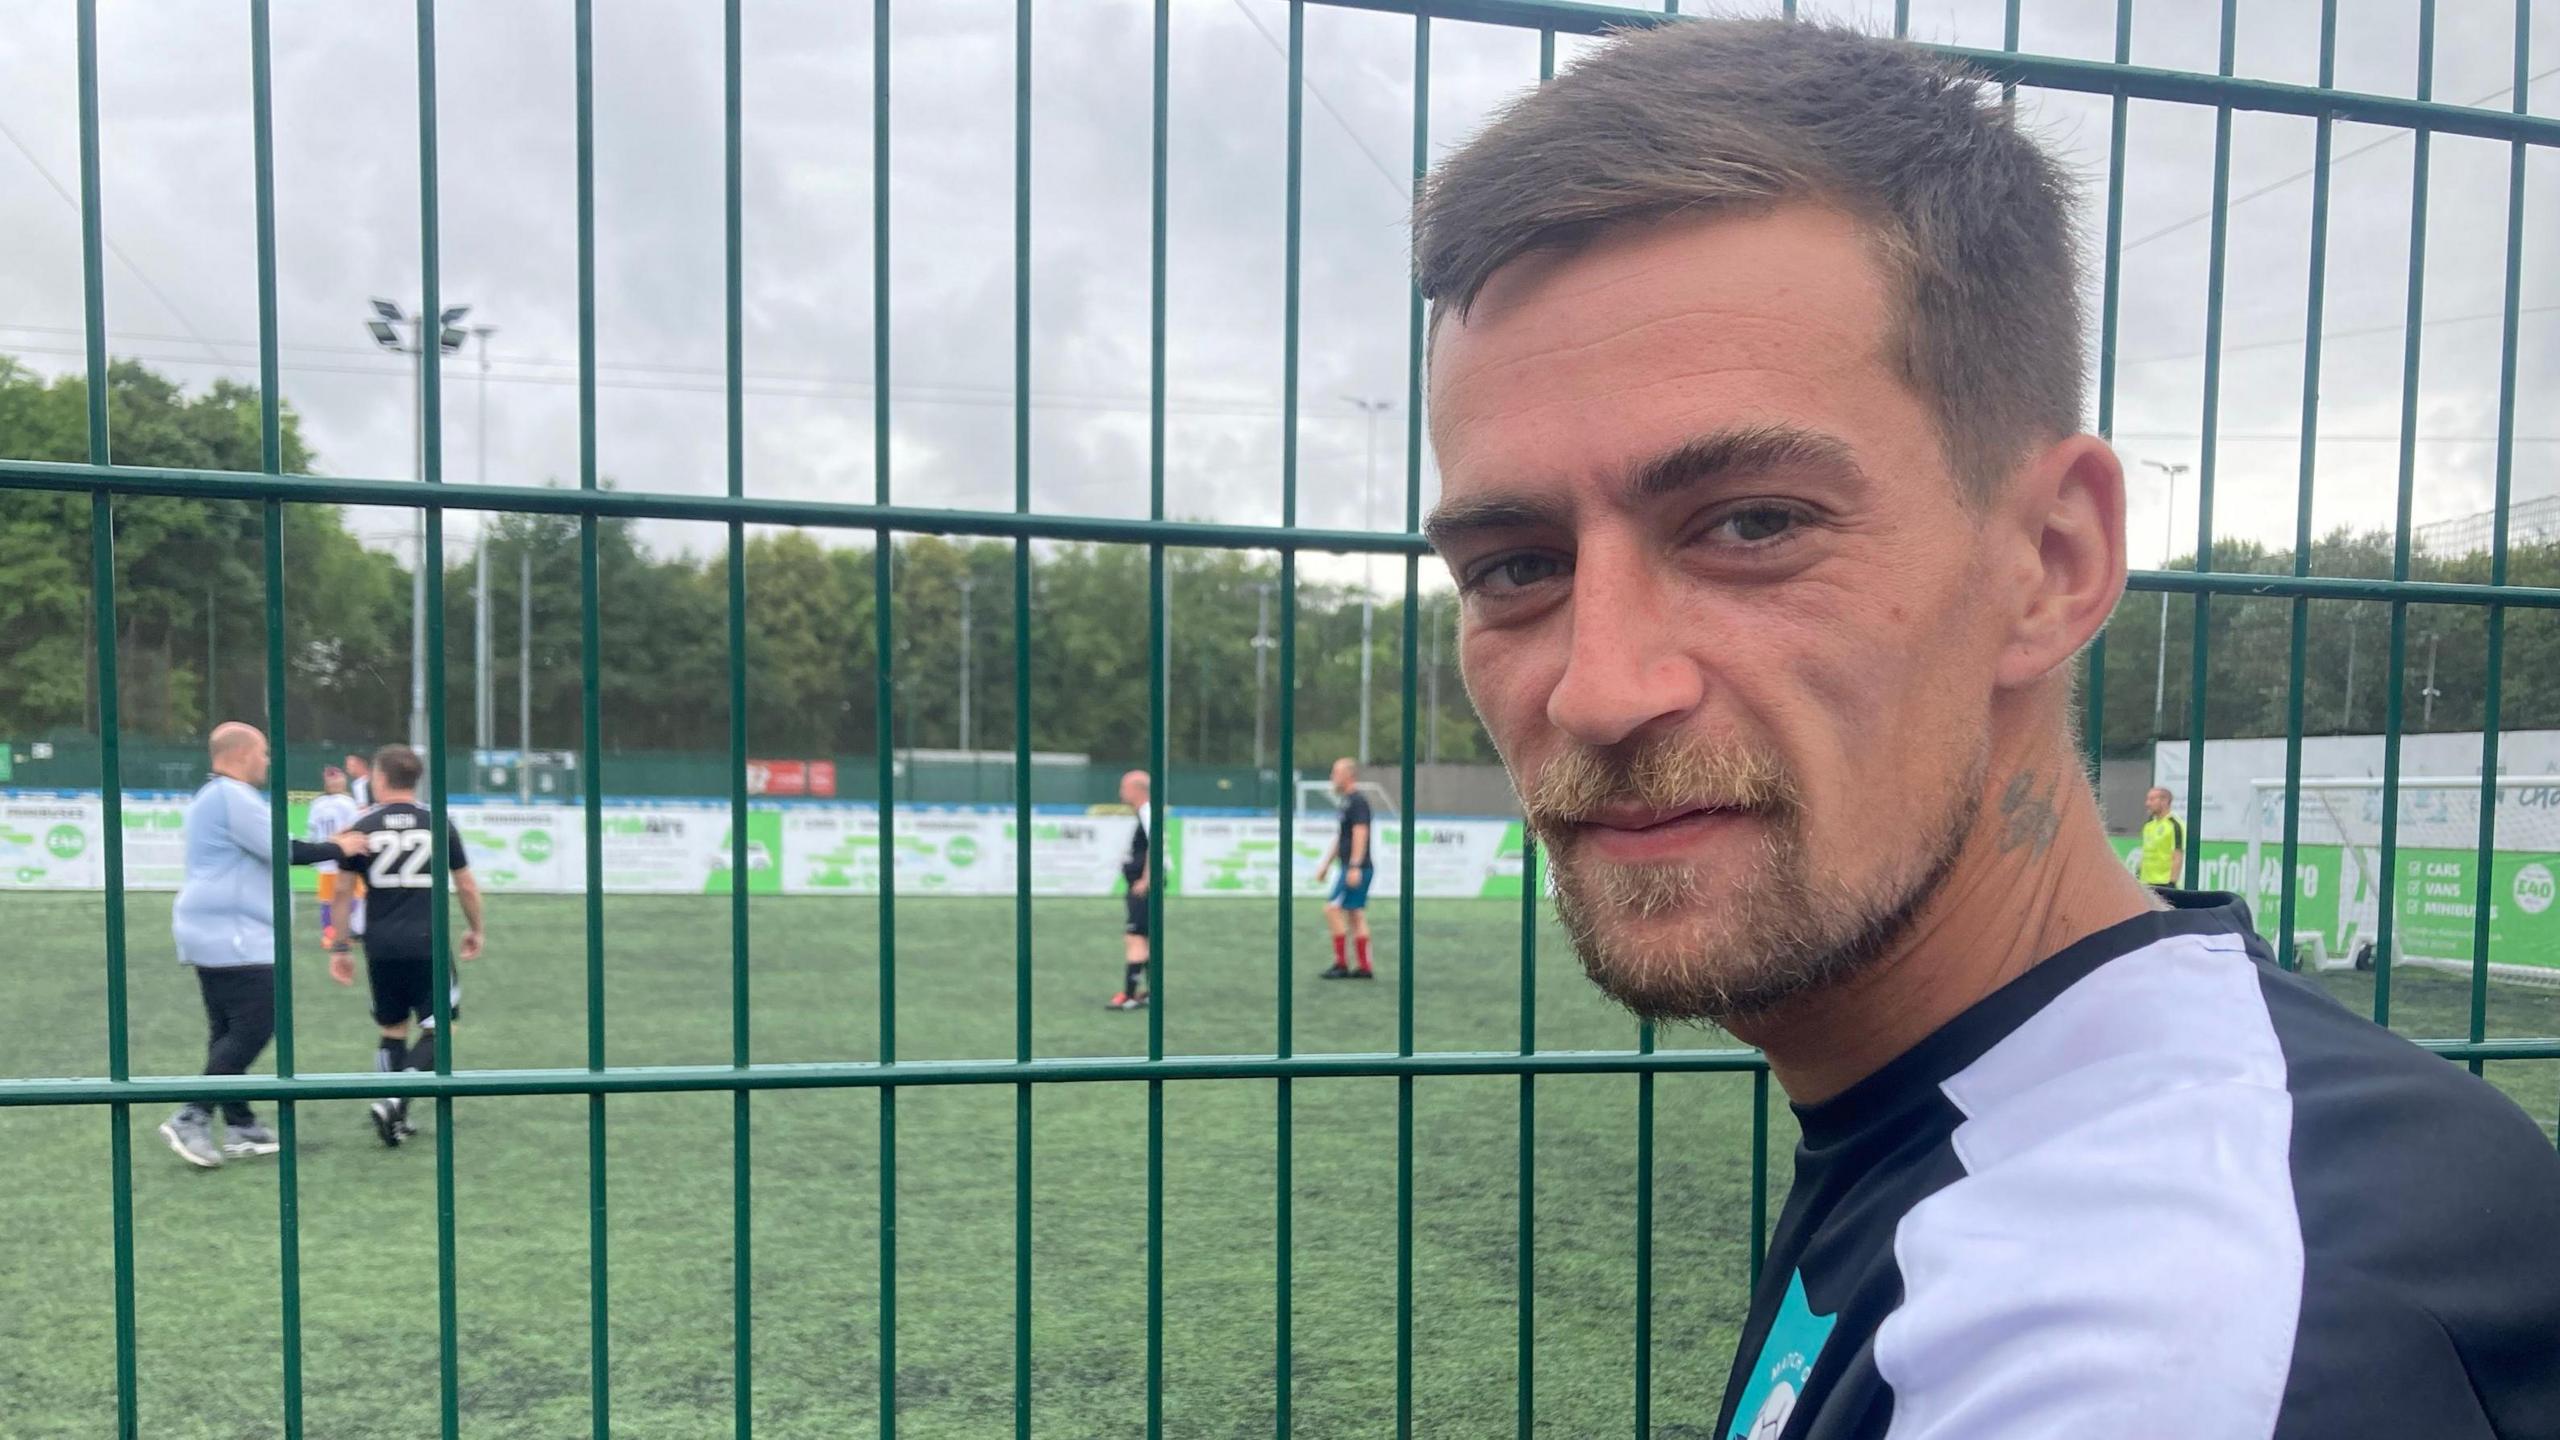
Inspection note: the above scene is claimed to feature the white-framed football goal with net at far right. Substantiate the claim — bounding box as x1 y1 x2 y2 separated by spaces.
2243 776 2560 984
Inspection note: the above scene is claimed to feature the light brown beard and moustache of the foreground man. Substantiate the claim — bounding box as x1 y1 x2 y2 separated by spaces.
1523 738 1989 1025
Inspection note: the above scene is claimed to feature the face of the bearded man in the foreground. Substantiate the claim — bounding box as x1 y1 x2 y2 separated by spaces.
1431 205 2004 1020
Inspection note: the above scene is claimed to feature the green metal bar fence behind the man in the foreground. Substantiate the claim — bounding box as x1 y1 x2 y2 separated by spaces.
0 0 2560 1437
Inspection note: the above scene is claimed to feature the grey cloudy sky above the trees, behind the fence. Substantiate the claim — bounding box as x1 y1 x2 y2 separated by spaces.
0 0 2560 584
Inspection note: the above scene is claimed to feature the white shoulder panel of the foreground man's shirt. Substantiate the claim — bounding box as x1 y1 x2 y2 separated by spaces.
1876 935 2301 1437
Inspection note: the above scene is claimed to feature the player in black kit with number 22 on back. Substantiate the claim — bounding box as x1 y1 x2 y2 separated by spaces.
330 746 481 1145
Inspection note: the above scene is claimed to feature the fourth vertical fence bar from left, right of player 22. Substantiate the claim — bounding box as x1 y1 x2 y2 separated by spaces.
576 0 614 1440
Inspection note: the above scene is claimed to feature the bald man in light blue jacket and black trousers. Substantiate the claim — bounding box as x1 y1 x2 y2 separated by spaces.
161 720 364 1171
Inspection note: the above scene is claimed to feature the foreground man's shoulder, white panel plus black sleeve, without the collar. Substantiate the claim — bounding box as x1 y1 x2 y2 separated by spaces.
1876 933 2560 1437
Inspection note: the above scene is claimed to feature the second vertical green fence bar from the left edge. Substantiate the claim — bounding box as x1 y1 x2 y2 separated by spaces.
248 0 302 1440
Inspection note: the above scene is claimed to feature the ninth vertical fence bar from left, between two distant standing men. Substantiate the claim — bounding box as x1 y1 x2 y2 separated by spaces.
1274 0 1306 1440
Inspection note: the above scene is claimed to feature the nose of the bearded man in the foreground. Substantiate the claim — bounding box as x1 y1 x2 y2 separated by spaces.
1546 536 1708 746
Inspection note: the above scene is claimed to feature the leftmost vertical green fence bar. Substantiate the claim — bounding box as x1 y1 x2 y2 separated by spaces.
77 0 141 1440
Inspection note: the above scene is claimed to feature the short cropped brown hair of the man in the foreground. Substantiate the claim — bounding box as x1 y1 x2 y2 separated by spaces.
1413 18 2084 500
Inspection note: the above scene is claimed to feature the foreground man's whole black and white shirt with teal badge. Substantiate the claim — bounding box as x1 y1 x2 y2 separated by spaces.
1715 894 2560 1440
